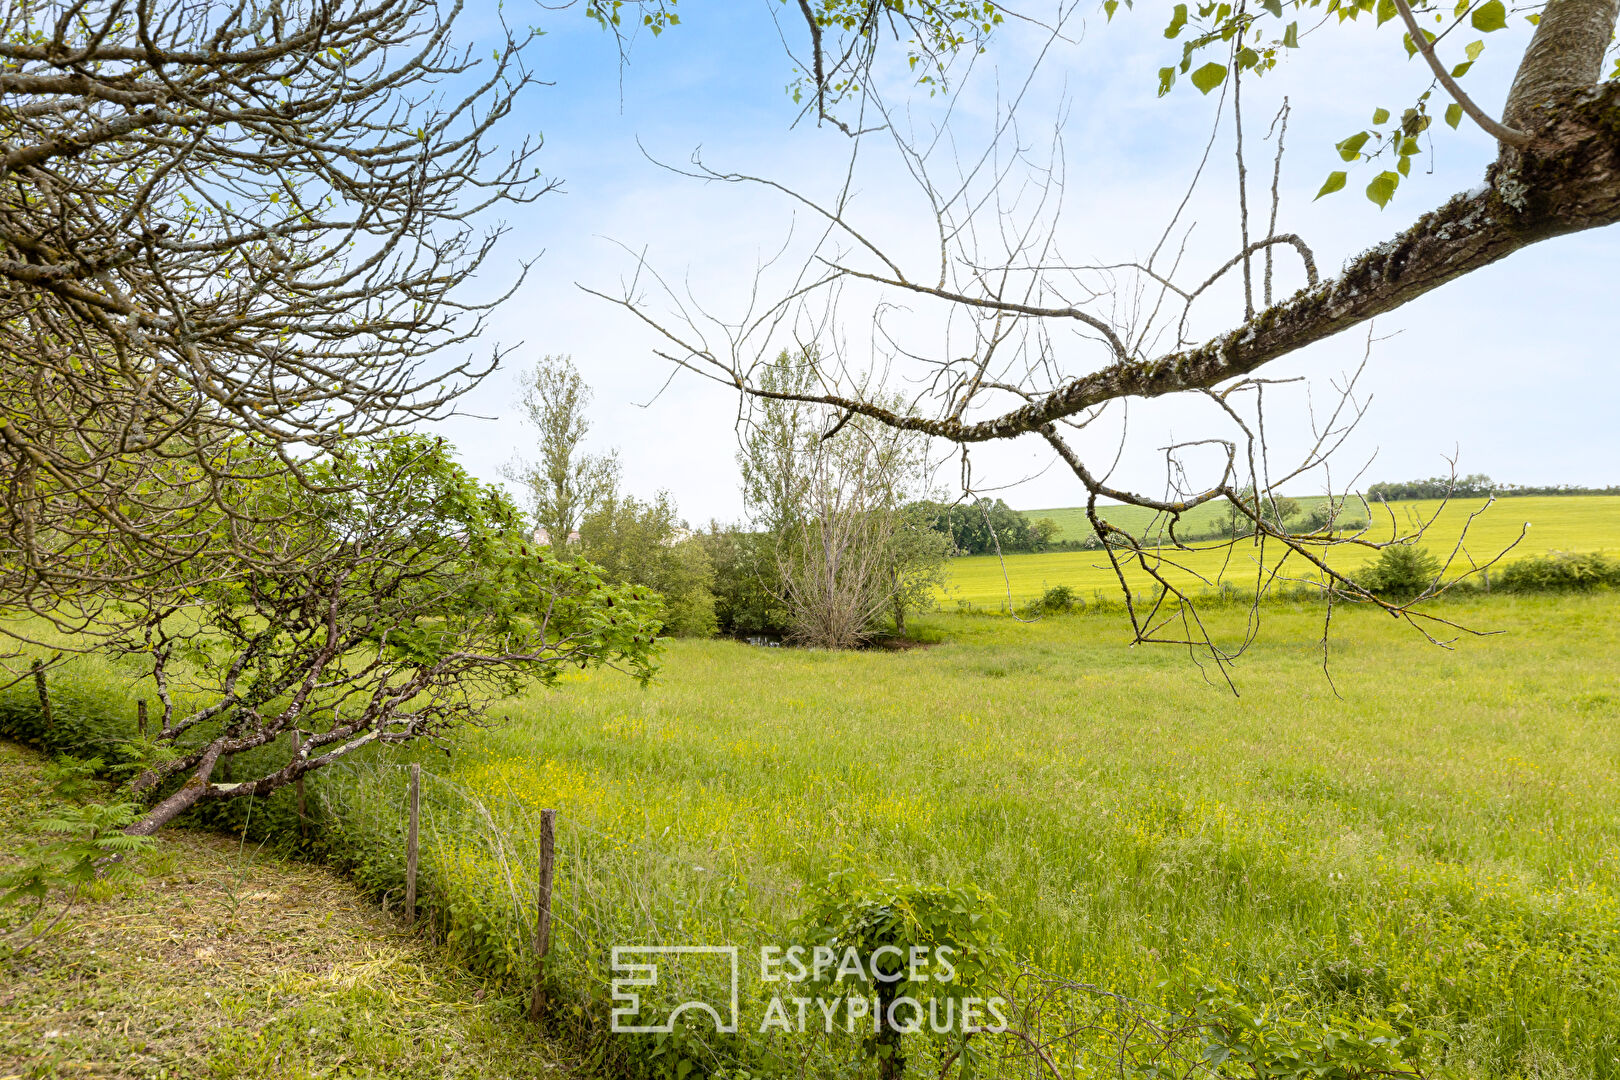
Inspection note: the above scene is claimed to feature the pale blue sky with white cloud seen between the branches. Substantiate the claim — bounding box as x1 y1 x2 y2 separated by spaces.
424 0 1620 523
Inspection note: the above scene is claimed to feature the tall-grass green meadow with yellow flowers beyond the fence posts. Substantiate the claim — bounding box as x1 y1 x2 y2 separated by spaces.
301 594 1620 1077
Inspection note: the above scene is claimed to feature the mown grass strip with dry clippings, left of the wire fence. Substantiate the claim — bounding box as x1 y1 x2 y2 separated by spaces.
0 742 569 1080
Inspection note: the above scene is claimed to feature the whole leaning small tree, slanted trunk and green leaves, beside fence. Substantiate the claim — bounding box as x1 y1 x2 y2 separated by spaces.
58 436 659 827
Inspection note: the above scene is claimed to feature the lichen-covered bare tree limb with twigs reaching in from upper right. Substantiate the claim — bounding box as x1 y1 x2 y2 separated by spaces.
586 0 1620 670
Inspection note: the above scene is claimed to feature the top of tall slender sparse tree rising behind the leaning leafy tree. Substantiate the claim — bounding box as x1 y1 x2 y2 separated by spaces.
504 356 619 552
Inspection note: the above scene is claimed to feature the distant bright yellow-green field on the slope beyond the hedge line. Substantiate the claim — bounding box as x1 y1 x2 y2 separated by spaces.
941 495 1620 610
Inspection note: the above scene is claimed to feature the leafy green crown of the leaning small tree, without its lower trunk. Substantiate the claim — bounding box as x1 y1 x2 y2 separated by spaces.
164 436 656 696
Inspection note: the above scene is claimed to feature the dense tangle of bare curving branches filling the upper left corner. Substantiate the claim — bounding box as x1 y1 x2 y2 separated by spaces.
0 0 549 631
